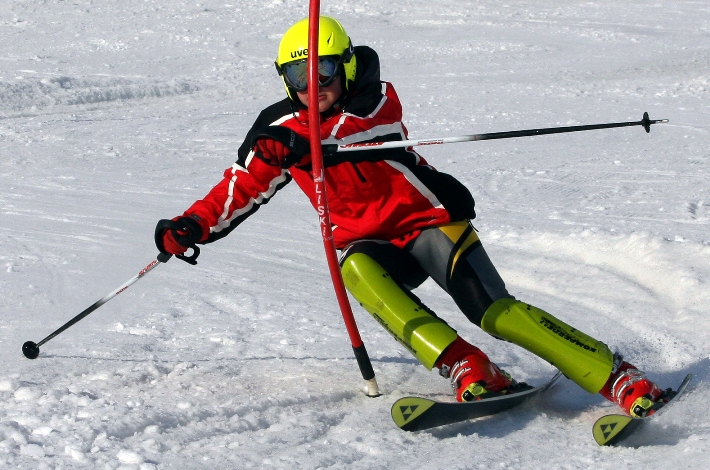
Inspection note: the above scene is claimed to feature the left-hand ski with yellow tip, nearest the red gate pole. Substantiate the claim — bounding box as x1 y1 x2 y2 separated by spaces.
392 372 562 431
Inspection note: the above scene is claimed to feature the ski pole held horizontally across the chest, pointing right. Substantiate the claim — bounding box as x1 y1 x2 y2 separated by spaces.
323 113 668 156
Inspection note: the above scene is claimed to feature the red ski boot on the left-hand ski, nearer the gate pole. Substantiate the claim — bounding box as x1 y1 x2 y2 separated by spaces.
436 336 527 402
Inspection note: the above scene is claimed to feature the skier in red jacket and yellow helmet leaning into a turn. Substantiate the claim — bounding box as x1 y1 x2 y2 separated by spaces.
156 17 668 417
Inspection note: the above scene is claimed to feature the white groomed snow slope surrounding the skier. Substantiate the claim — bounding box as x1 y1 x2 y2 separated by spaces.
0 0 710 470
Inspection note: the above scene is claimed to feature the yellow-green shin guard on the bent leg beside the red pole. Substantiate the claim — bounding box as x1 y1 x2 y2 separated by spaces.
342 253 458 369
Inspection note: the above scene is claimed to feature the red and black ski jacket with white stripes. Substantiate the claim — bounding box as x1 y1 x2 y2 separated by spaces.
184 46 475 248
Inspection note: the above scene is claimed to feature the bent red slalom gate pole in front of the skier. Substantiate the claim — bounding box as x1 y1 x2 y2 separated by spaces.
308 0 380 397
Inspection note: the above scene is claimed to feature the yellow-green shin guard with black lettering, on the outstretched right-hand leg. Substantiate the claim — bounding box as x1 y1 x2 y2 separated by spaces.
481 299 614 393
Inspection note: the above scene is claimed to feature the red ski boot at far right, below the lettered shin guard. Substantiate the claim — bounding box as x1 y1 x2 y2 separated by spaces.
599 353 674 418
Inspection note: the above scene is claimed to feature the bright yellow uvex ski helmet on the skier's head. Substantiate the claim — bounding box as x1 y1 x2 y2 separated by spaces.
275 16 357 103
